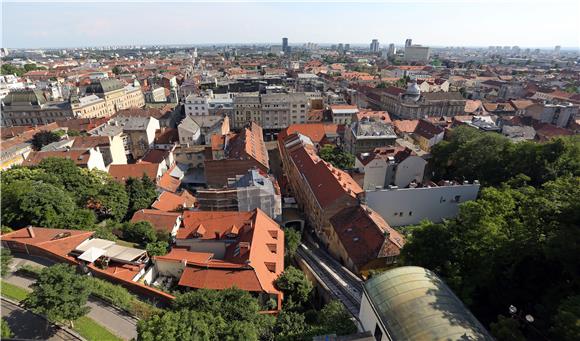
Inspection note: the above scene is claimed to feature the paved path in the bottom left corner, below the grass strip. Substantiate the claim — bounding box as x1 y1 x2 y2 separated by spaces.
2 299 82 341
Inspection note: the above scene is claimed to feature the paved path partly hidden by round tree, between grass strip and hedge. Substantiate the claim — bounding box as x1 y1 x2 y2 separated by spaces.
4 255 137 340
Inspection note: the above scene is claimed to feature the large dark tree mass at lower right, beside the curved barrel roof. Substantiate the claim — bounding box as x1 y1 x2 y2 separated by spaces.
402 177 580 340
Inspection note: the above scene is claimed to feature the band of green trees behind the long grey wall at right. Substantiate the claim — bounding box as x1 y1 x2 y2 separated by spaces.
429 126 580 186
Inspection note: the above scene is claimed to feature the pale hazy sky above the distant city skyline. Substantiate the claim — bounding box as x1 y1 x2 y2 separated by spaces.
0 0 580 48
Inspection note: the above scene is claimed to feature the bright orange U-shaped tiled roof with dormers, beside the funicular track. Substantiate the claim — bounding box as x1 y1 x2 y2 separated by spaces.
172 209 284 294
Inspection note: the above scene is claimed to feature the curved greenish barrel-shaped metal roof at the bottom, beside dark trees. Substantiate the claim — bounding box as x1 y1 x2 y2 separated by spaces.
365 266 493 341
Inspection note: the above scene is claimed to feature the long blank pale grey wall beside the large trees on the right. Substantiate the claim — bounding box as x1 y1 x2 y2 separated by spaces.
366 184 479 226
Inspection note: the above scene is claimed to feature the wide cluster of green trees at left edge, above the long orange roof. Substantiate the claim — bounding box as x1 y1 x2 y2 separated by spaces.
1 158 142 229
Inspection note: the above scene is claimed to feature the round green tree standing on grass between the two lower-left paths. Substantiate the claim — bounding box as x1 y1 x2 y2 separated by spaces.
24 264 90 326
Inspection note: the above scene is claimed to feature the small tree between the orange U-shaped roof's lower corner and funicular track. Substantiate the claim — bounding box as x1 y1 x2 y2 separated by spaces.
276 266 313 309
